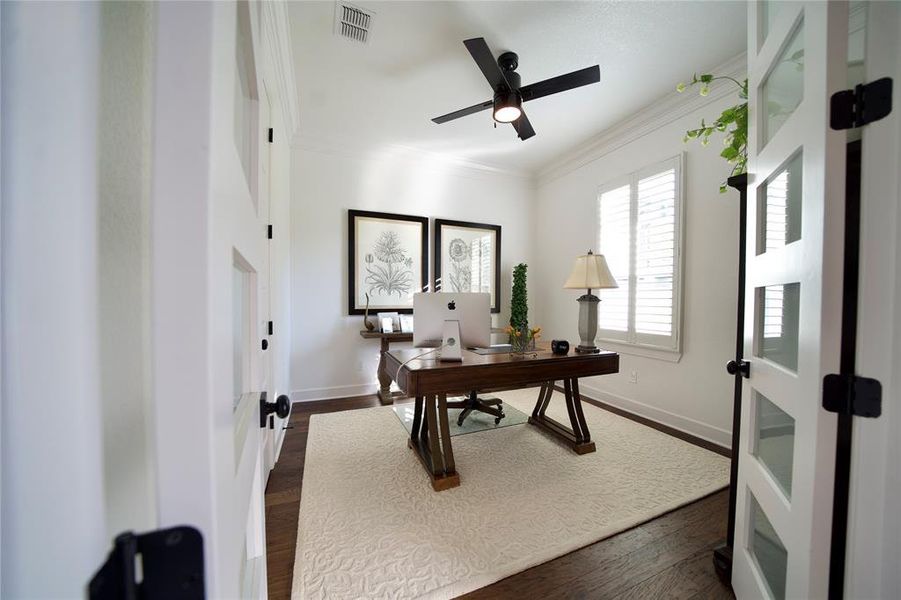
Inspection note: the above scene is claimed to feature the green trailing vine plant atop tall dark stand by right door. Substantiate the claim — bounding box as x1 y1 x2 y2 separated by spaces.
676 73 748 194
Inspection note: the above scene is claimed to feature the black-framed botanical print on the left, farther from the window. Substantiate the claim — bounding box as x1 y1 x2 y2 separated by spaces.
347 210 429 315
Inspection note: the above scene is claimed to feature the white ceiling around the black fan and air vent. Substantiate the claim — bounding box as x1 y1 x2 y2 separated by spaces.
289 1 747 172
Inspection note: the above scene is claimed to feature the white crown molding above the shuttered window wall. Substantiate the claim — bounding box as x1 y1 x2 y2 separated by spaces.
536 52 747 187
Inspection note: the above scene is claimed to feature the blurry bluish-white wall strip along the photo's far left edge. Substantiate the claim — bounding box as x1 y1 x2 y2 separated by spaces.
0 2 109 598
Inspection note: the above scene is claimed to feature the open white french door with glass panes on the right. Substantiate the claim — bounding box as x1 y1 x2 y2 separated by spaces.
732 2 848 599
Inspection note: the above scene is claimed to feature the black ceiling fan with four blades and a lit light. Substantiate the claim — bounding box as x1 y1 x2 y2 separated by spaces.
432 38 601 140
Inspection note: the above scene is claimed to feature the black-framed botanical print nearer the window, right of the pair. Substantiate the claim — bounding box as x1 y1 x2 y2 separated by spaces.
434 219 501 313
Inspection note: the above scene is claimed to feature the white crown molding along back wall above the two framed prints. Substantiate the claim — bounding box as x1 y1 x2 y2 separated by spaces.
291 134 534 183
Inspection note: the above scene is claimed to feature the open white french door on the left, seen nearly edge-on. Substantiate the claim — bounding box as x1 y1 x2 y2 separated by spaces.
152 2 272 598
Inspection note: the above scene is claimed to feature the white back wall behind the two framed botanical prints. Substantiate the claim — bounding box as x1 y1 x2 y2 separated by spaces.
291 147 535 401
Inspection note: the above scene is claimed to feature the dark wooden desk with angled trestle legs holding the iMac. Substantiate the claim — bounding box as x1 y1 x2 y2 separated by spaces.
384 344 619 491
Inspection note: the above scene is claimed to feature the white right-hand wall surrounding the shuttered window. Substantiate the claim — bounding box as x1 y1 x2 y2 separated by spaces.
533 92 738 446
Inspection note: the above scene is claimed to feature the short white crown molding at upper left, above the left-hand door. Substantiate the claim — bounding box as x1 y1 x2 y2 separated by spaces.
260 0 300 140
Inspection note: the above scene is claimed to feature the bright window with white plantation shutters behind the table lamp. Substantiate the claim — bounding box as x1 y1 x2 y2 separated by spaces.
598 157 682 352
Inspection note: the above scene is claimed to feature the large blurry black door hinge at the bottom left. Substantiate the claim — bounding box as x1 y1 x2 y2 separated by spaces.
88 525 206 600
